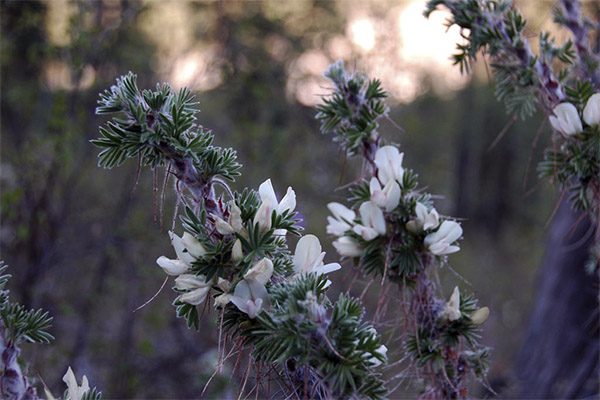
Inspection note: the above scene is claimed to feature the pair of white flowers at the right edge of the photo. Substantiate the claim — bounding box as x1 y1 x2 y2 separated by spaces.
549 93 600 137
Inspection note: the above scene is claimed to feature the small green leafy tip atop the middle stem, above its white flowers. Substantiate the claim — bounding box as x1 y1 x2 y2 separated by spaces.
316 61 388 155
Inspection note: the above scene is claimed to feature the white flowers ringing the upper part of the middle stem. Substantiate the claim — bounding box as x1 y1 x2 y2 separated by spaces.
327 146 462 258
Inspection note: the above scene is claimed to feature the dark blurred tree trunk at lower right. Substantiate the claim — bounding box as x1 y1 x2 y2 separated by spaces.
516 200 600 399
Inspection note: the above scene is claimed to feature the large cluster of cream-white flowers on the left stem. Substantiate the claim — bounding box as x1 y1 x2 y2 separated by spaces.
156 179 341 319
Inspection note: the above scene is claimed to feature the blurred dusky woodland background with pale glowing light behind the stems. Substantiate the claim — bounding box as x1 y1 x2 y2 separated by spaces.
0 0 565 398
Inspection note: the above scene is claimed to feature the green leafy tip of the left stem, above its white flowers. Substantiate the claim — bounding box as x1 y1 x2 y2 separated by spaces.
92 72 241 181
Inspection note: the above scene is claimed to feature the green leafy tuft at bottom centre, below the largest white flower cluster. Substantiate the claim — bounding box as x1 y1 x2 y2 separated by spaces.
232 273 386 399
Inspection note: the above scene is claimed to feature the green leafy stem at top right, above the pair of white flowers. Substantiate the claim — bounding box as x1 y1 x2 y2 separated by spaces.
424 0 575 119
